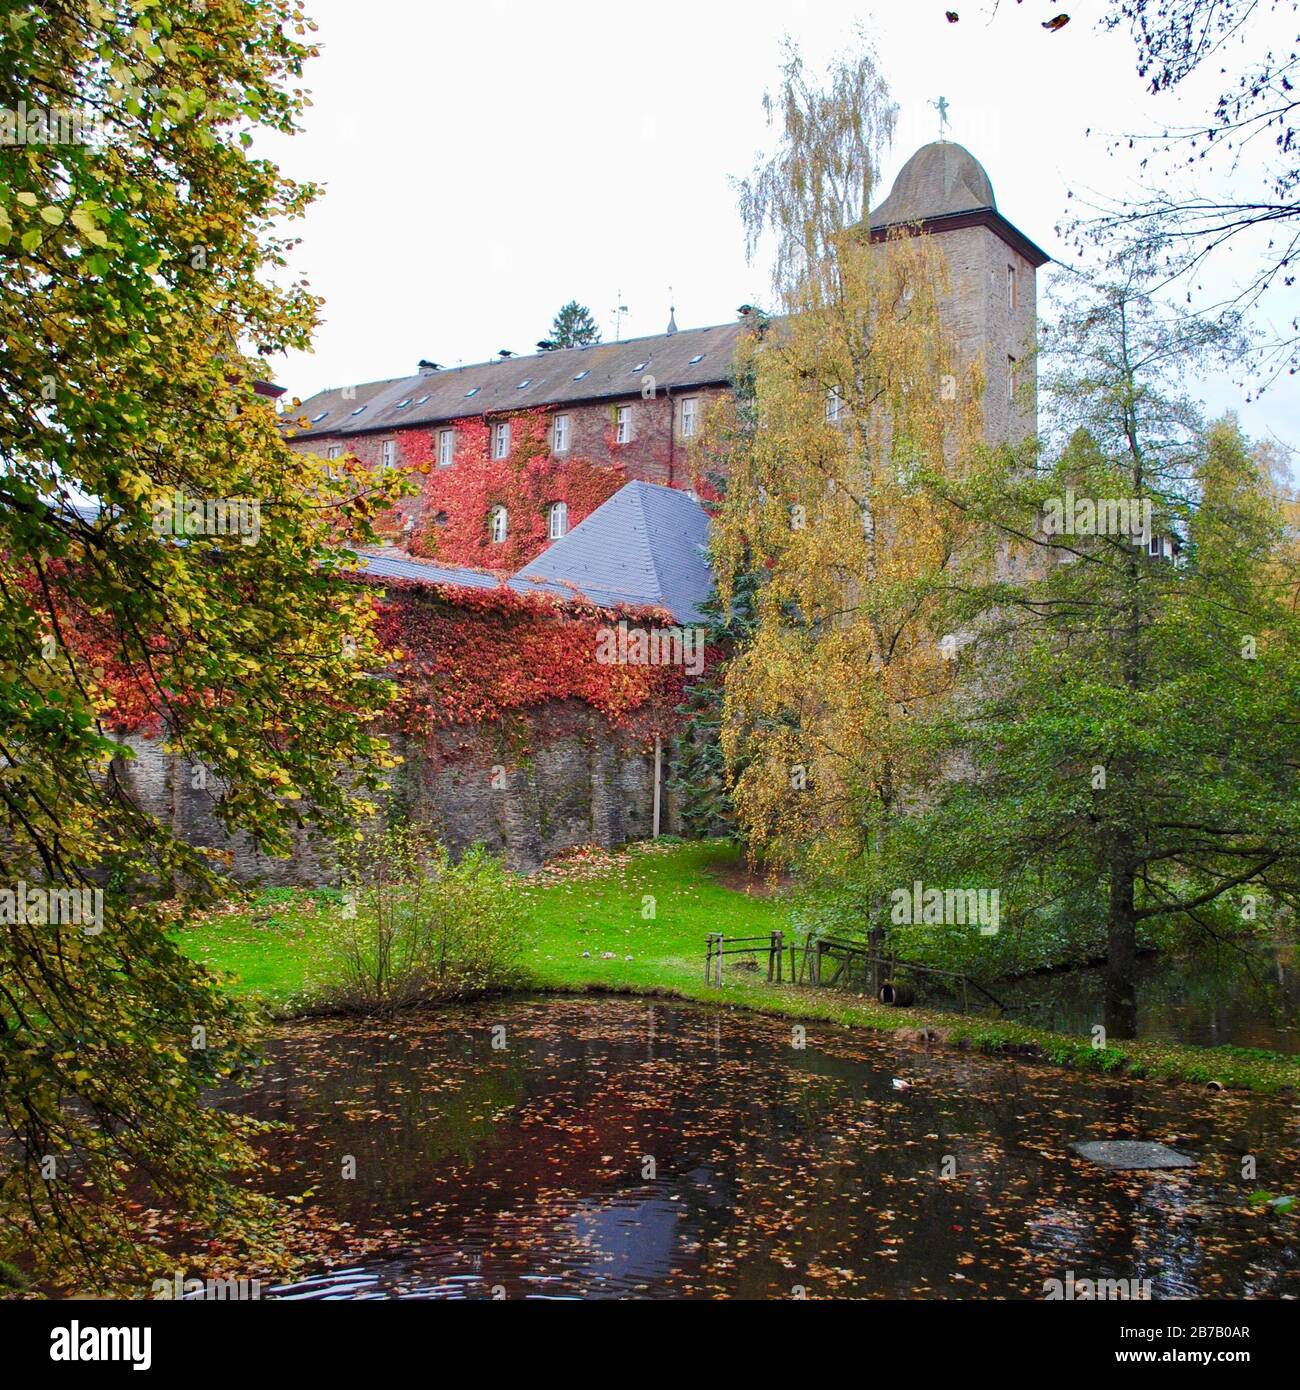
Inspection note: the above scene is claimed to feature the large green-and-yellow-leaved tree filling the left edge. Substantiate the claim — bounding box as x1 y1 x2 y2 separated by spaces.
0 0 405 1289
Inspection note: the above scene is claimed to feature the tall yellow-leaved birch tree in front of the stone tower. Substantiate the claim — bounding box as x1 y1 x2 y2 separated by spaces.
699 35 989 967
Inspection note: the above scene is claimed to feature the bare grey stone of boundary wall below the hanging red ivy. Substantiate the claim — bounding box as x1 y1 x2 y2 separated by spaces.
117 699 680 887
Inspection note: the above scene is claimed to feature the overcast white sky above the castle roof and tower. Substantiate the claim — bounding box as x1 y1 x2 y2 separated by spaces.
260 0 1300 443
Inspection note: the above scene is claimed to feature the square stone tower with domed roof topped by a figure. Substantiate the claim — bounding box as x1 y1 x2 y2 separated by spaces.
870 140 1051 441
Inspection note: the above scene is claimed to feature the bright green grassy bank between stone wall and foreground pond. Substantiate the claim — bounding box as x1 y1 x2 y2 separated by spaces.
181 844 1300 1091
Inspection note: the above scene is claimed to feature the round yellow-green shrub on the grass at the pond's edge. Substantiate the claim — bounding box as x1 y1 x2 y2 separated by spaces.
309 827 521 1013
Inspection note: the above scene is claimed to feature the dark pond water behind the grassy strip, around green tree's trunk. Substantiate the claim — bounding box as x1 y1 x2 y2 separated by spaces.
994 948 1300 1054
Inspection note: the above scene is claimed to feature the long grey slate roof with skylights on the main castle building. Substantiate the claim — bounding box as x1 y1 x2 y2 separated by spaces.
292 322 741 439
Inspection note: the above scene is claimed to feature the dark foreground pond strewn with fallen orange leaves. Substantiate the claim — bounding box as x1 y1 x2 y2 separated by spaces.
233 999 1300 1298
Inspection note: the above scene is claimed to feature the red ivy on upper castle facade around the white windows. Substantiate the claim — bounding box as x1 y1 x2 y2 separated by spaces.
403 410 627 573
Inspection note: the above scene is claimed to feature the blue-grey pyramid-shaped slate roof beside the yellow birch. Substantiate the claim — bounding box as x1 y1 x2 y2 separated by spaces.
510 482 713 623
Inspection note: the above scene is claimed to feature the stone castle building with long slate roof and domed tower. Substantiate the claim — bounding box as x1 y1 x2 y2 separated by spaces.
292 140 1050 588
